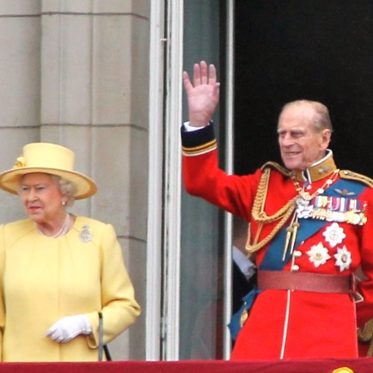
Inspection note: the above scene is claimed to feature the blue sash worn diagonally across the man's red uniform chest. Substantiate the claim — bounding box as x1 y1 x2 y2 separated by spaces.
259 179 366 271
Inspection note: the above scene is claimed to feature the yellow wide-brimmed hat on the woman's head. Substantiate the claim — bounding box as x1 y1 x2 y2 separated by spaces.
0 142 97 199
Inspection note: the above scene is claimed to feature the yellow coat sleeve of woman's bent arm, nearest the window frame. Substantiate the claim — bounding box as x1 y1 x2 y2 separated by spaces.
88 224 141 348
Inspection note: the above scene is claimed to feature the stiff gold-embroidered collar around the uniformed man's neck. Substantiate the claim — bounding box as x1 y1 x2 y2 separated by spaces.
291 149 337 183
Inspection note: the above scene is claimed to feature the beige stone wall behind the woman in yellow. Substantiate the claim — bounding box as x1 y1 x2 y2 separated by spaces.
0 0 150 360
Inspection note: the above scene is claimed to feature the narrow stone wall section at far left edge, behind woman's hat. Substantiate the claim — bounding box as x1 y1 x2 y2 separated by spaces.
0 0 40 219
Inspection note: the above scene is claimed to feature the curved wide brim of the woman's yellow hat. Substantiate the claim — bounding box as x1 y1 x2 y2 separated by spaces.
0 167 97 199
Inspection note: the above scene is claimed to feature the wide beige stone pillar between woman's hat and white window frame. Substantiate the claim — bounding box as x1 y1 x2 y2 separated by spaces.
41 0 150 360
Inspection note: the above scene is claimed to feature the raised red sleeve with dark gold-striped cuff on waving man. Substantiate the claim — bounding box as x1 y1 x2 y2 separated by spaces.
181 123 262 221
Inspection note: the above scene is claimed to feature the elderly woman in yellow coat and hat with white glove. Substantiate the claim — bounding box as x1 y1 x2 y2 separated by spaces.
0 143 140 361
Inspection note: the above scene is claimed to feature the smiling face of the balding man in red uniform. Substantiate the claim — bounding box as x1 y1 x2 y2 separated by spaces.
277 105 330 171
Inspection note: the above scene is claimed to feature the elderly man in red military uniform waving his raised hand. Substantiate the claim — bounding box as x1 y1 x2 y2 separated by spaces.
182 61 373 360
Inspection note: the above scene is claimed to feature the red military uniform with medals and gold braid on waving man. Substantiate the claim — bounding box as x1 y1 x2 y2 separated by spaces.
182 125 373 360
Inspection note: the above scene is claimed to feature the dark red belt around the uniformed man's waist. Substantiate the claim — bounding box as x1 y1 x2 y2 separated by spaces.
257 270 355 293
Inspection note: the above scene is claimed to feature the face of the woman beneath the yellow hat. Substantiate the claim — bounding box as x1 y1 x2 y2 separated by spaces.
19 173 66 224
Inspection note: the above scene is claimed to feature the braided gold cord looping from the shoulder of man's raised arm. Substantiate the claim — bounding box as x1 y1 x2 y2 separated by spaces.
246 168 297 254
